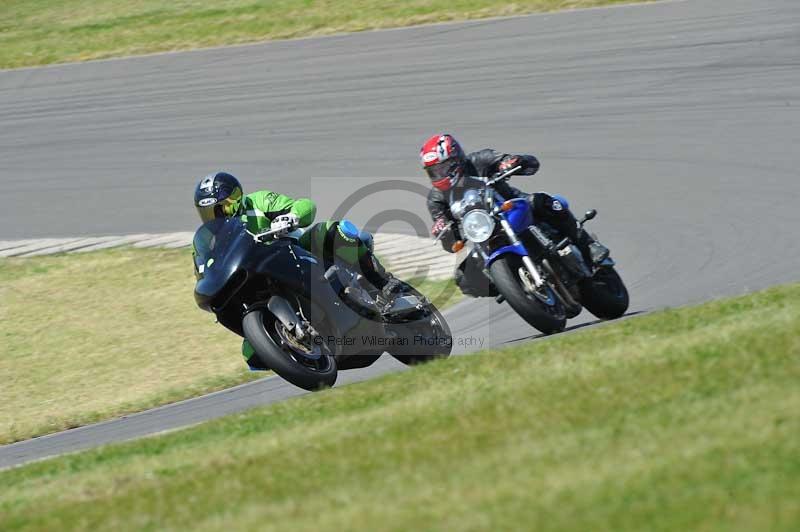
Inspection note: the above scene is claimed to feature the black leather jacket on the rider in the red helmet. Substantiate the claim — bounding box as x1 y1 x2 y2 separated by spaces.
428 148 539 224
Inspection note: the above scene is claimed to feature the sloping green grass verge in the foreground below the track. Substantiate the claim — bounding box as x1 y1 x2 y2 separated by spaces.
0 285 800 532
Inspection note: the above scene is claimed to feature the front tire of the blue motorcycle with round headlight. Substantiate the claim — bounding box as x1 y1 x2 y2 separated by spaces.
489 255 567 334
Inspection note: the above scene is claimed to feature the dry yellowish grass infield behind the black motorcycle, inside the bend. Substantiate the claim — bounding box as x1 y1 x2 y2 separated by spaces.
0 248 460 444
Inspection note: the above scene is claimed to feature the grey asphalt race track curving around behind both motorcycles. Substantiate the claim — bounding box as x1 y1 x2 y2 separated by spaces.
0 0 800 467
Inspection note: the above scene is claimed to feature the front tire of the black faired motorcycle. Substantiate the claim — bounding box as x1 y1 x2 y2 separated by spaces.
242 310 338 391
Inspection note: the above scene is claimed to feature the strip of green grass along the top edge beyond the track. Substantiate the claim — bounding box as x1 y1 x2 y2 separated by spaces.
0 0 648 68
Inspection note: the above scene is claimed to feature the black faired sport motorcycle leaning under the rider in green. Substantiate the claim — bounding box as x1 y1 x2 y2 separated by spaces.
193 218 453 390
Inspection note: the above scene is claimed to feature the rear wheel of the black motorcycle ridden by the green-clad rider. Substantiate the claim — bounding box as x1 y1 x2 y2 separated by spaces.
389 283 453 366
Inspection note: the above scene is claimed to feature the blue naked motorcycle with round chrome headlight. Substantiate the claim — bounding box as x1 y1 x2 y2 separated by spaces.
442 167 629 334
